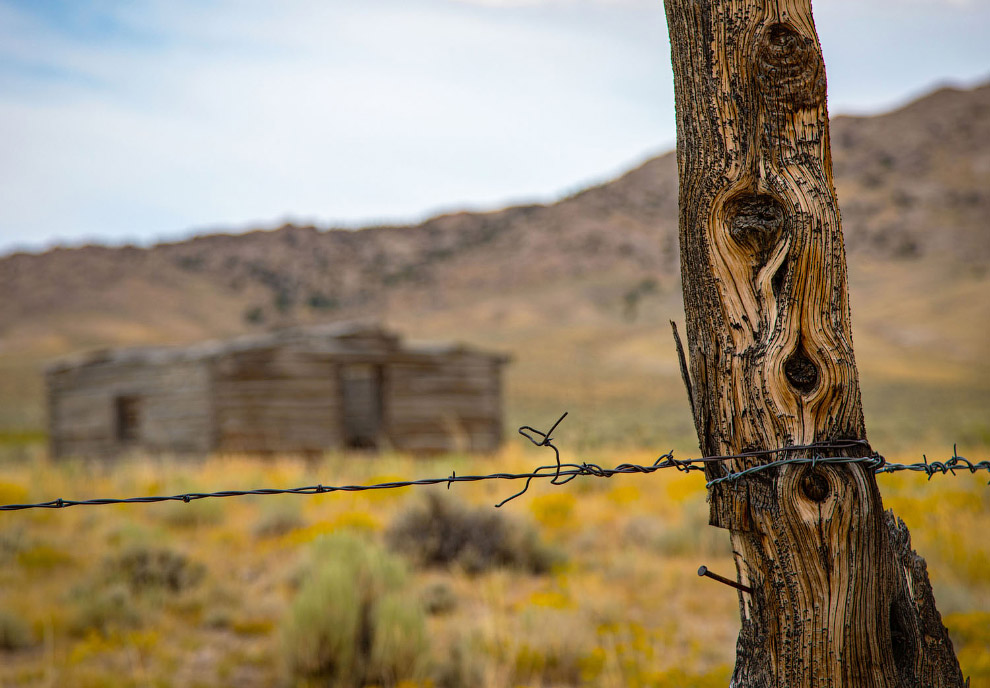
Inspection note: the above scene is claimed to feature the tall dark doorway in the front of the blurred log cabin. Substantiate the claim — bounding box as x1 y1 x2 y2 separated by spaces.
340 363 385 449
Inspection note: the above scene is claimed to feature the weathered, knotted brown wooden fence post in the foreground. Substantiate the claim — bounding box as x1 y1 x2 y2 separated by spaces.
665 0 963 688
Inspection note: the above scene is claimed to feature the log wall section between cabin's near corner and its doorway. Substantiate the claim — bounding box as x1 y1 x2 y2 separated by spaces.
213 348 342 452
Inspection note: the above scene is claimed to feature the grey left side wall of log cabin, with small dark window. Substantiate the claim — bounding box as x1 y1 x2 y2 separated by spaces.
46 361 212 457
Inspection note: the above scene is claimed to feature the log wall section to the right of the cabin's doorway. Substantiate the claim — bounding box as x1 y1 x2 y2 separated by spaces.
385 352 502 453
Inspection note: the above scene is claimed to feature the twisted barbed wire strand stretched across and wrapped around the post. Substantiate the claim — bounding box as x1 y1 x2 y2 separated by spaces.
0 413 990 511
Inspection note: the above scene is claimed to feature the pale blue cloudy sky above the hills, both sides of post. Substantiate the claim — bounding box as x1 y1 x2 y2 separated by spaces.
0 0 990 254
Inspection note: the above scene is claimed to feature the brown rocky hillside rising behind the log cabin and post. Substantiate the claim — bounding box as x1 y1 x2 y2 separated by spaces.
0 85 990 452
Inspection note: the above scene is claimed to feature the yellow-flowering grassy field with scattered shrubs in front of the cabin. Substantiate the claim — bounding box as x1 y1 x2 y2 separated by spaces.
0 438 990 688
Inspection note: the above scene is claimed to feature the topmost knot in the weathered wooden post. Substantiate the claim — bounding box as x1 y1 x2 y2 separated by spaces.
757 24 825 109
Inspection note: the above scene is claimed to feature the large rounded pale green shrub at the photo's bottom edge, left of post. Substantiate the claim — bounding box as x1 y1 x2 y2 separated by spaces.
281 532 427 686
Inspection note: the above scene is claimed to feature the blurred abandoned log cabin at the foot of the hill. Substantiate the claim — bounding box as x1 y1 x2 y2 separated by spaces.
45 323 509 457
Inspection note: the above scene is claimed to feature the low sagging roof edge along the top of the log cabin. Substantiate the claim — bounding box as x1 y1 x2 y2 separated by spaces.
46 320 509 373
